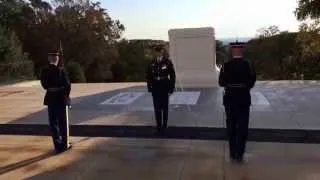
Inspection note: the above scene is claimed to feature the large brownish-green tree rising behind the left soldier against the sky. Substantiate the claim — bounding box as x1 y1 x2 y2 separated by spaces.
0 0 124 82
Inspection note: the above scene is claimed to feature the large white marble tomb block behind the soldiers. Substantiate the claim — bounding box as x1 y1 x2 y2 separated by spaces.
169 27 219 88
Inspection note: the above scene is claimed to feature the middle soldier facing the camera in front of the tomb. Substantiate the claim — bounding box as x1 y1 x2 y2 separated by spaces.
147 46 176 132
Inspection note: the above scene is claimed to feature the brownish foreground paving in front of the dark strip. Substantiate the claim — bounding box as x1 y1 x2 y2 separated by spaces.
0 136 320 180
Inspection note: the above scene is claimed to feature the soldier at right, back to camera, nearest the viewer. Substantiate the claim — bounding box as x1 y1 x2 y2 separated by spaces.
219 42 256 162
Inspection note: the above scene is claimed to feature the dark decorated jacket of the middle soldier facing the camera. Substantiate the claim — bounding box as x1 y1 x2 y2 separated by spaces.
147 58 176 93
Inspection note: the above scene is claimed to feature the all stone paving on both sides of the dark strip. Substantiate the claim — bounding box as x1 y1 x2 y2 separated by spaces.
0 81 320 180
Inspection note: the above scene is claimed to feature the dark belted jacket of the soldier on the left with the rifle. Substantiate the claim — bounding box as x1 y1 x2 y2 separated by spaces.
41 64 71 105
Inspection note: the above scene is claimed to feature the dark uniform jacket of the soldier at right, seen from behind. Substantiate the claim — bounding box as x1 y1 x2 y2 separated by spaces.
219 59 256 106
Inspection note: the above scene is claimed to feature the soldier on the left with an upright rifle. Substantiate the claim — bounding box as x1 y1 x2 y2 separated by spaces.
41 52 71 153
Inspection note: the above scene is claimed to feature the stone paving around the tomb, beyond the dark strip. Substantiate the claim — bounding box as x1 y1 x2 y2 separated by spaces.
0 81 320 130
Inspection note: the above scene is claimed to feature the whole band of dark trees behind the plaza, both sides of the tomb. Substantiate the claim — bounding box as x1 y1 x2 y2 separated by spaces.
0 0 320 82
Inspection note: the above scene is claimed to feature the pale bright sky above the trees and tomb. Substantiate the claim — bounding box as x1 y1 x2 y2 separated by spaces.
100 0 299 40
